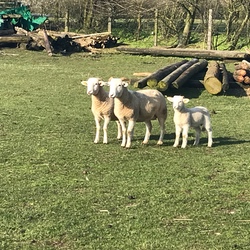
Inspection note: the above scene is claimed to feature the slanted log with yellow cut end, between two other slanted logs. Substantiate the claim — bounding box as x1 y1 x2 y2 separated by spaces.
157 58 199 92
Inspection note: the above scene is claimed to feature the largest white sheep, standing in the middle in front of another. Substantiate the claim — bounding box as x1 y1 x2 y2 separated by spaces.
108 78 167 148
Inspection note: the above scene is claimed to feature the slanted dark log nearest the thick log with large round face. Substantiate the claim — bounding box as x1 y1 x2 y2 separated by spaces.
172 59 208 89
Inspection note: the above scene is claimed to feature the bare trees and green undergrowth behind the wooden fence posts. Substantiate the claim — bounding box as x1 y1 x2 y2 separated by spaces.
23 0 250 50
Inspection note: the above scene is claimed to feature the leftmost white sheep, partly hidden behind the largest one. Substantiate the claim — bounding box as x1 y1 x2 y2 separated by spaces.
81 77 122 143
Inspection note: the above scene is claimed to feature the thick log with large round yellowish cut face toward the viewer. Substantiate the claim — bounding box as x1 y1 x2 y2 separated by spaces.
204 61 222 95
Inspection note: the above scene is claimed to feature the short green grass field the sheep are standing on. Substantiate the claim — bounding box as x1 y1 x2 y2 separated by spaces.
0 49 250 250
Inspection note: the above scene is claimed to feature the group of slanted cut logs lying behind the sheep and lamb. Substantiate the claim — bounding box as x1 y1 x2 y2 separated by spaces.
134 58 244 95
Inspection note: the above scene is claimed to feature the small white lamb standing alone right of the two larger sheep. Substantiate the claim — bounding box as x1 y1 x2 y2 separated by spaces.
167 95 213 148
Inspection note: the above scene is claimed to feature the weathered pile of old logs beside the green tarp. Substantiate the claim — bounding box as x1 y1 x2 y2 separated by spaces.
1 27 119 53
